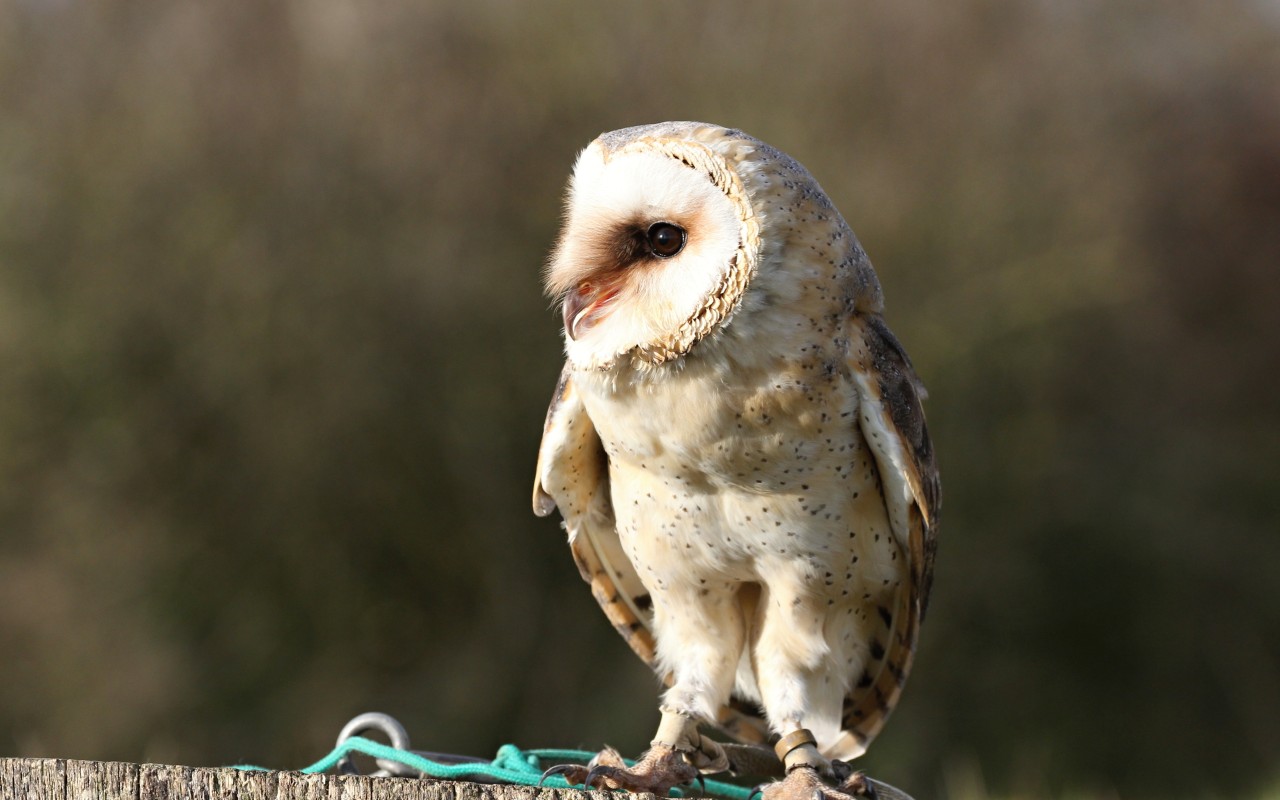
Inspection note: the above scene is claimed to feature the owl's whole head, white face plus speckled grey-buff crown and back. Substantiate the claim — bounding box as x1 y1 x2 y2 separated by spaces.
545 122 879 369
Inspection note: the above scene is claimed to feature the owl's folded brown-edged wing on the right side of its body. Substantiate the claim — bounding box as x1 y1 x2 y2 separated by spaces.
836 315 942 758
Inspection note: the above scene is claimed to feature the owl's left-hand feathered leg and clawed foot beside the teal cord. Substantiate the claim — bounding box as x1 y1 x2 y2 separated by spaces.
547 584 745 795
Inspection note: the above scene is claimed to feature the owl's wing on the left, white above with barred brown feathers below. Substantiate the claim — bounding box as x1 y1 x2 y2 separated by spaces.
534 364 768 742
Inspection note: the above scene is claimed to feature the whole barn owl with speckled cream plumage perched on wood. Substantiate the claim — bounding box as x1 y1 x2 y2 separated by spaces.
534 122 940 800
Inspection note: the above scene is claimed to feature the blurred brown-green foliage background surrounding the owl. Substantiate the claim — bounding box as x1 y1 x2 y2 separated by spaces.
0 0 1280 799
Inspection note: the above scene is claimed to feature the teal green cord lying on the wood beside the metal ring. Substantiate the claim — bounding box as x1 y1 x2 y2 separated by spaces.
234 736 751 800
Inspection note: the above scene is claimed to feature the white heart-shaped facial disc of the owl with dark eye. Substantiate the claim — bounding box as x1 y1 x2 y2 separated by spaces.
547 129 759 369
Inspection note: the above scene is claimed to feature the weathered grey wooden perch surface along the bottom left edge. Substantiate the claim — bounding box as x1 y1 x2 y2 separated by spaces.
0 758 632 800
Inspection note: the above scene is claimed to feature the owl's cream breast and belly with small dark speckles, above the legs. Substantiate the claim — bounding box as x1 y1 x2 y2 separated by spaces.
584 340 904 614
